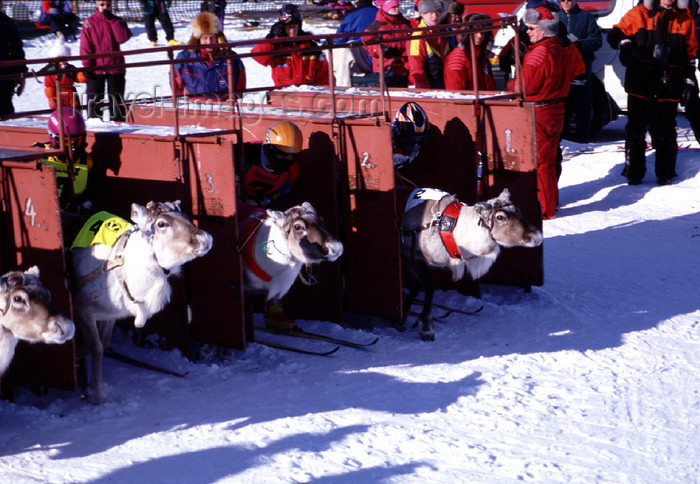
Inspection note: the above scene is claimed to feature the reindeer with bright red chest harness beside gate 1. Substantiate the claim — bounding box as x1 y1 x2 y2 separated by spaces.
394 188 542 341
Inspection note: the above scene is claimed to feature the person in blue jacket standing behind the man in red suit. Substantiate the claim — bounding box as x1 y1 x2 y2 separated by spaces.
559 0 603 143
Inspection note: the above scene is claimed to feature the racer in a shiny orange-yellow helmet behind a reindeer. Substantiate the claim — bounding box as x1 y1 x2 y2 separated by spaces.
244 121 304 207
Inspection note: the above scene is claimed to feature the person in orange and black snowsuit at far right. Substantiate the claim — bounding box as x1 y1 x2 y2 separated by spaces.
608 0 698 185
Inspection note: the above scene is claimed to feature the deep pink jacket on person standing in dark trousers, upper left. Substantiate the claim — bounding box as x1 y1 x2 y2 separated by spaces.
80 12 131 76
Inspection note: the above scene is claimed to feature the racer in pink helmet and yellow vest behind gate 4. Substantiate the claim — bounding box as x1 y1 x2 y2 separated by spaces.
34 107 92 208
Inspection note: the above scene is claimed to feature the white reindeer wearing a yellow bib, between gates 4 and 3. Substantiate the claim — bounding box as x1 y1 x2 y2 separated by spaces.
73 200 212 404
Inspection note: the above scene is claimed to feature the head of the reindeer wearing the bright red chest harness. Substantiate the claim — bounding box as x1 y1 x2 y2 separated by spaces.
474 188 543 247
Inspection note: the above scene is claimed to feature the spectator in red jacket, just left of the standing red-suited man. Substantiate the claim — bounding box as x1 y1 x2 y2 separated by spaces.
444 13 496 91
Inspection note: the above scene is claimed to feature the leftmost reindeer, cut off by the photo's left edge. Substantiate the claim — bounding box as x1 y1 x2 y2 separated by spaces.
0 266 75 376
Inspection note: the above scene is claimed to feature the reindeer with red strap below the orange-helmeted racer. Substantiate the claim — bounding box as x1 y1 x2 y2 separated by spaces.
240 202 343 326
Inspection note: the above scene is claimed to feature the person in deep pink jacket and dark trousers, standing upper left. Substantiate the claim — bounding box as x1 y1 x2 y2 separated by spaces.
80 0 131 121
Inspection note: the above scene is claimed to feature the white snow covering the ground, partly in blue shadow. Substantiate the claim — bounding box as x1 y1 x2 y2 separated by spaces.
0 19 700 484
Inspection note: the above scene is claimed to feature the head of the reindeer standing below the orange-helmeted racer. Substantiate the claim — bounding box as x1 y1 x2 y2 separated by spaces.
268 202 343 264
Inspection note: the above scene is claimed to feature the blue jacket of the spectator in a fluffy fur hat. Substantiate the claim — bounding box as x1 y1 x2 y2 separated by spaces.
176 50 245 95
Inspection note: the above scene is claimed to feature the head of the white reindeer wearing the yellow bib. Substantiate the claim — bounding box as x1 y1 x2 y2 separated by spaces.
131 200 212 271
